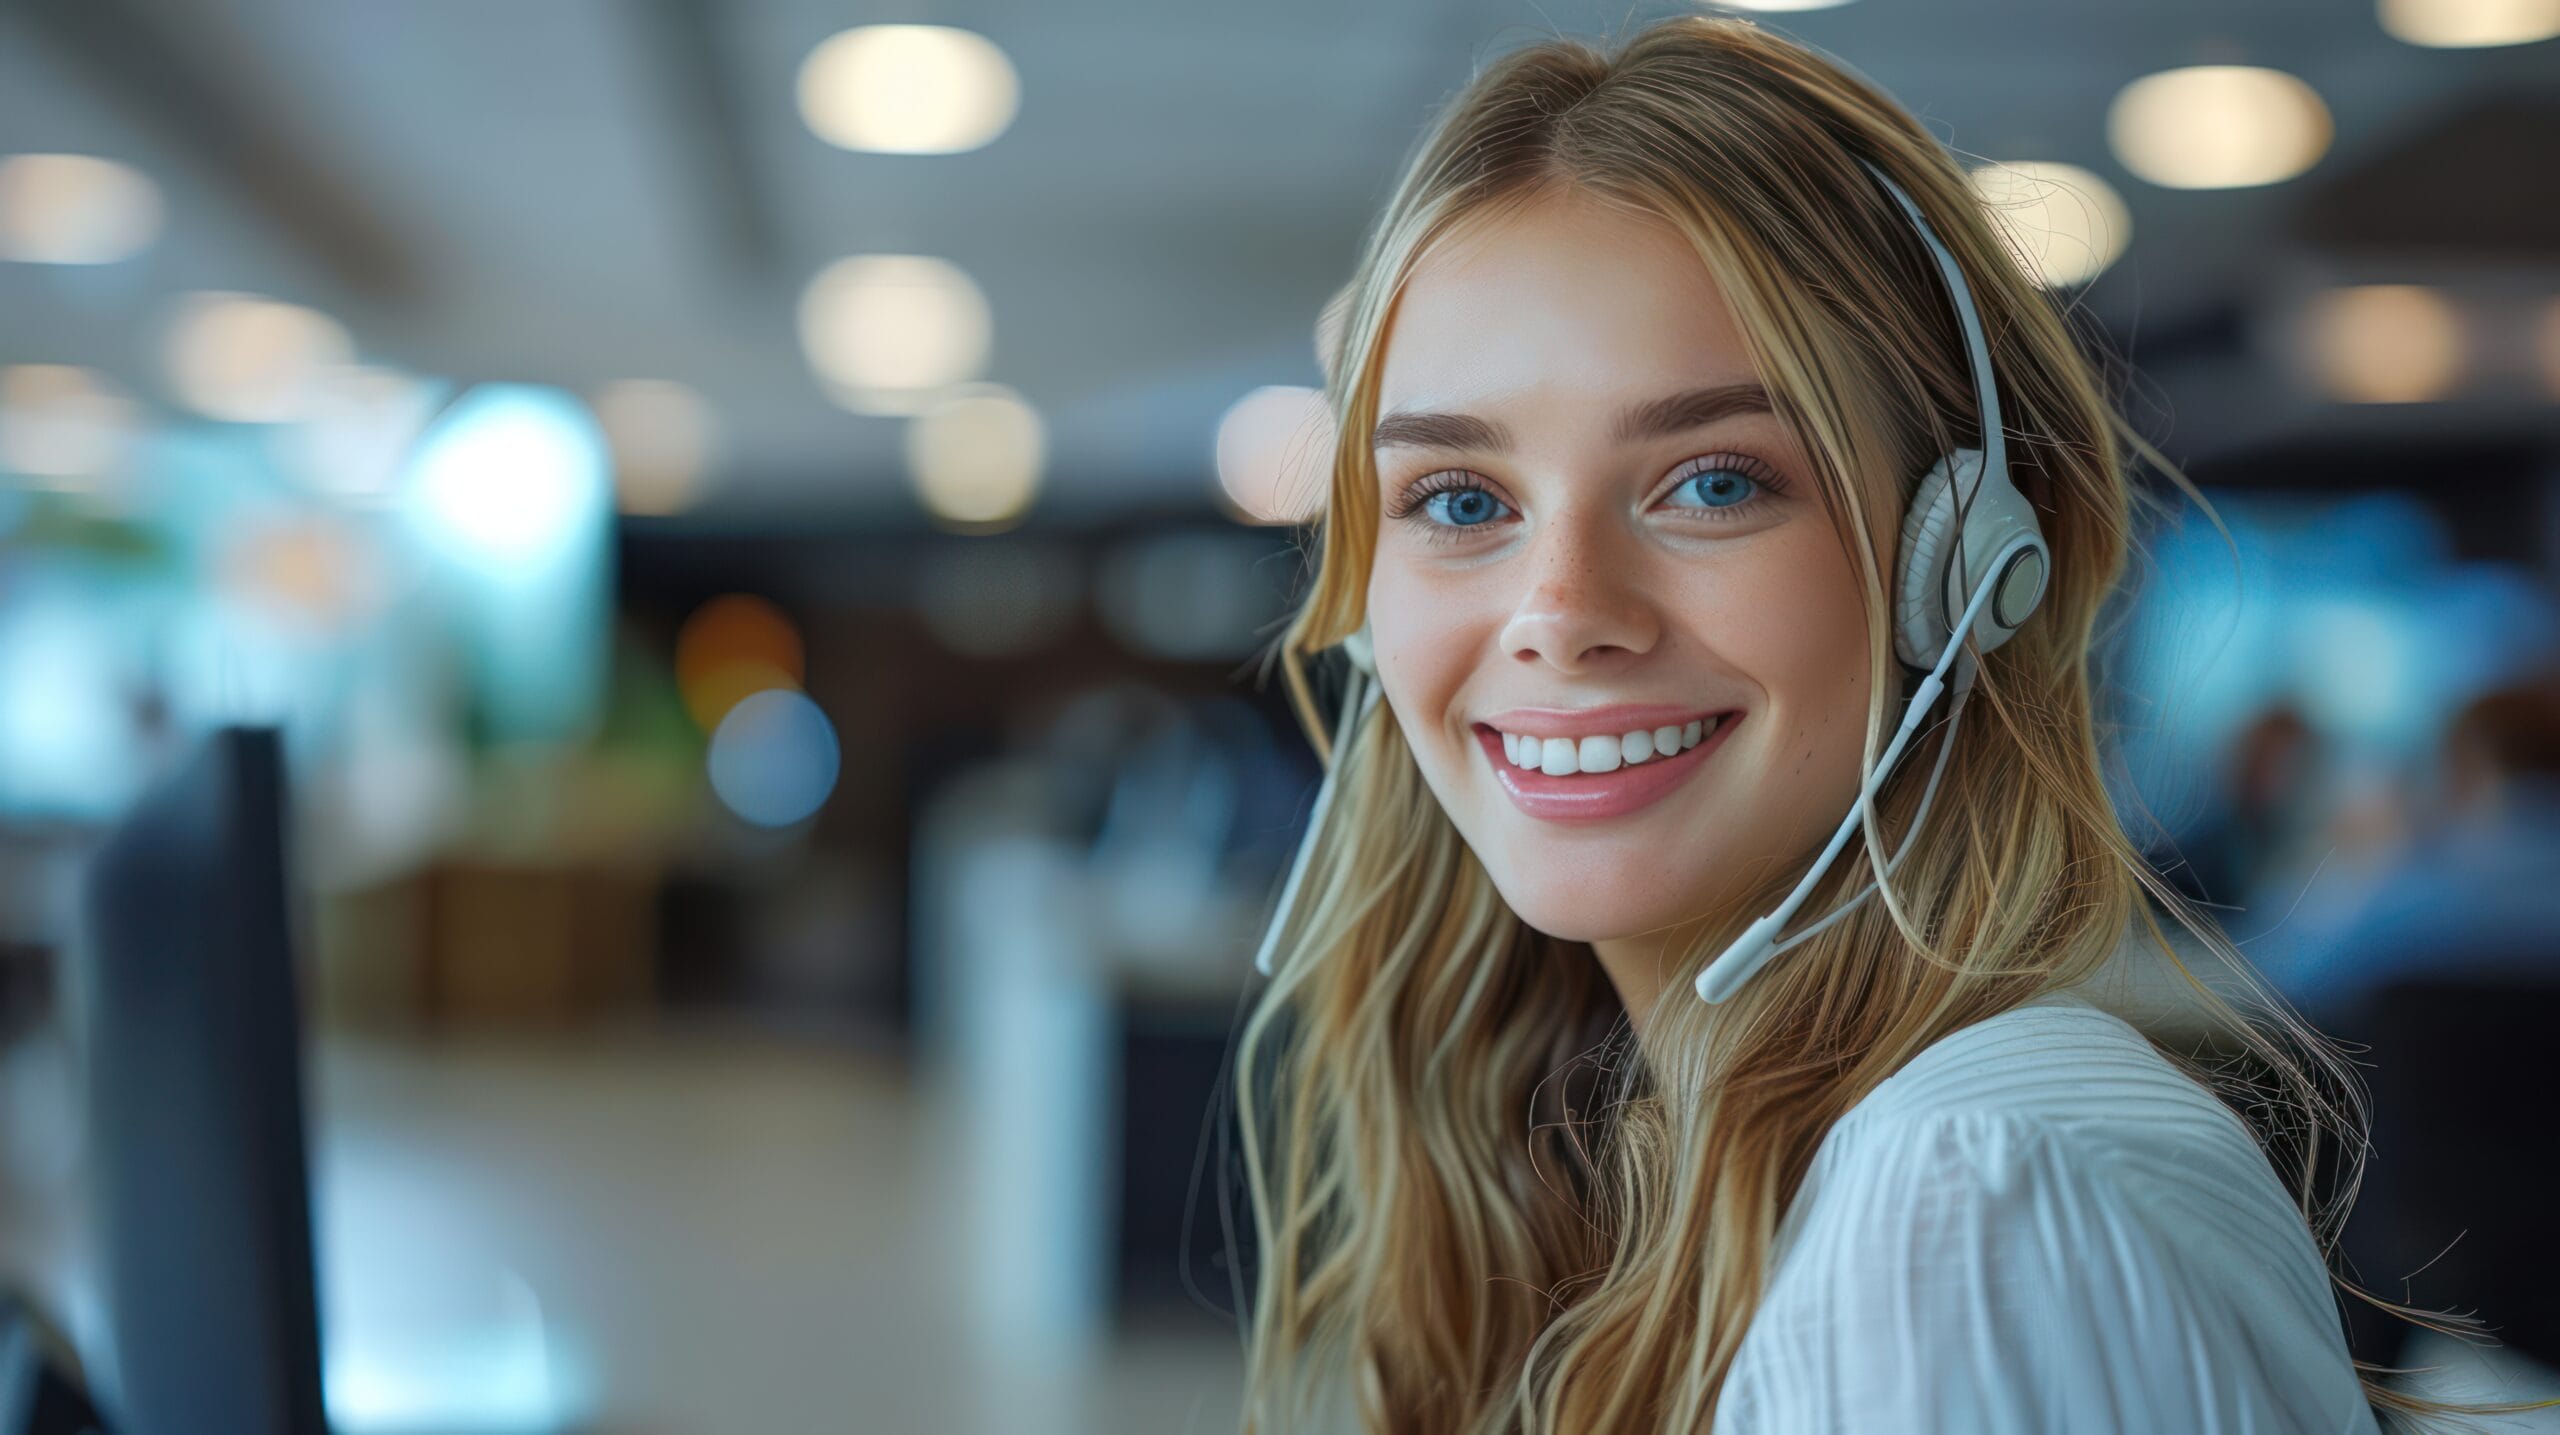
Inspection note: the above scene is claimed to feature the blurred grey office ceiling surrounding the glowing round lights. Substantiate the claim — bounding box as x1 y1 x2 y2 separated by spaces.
0 0 2560 527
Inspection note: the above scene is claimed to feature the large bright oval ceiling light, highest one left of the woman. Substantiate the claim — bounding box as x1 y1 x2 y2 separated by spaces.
799 26 1021 153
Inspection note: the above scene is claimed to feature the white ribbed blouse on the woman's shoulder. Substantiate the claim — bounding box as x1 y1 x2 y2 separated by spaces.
1715 995 2378 1435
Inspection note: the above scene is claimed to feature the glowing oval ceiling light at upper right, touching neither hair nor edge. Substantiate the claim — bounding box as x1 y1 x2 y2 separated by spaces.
2107 64 2330 189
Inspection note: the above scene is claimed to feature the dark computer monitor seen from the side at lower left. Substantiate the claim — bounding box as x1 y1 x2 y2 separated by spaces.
77 729 328 1435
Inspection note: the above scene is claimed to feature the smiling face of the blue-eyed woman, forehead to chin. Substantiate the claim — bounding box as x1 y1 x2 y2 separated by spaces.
1370 197 1869 941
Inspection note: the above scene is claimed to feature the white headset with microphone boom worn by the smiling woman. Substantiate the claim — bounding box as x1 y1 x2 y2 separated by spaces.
1254 161 2053 1003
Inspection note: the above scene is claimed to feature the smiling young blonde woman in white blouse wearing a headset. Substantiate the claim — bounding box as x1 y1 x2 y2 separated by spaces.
1239 18 2457 1435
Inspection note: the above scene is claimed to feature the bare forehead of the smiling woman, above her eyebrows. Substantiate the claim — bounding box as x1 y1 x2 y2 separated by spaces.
1377 192 1756 412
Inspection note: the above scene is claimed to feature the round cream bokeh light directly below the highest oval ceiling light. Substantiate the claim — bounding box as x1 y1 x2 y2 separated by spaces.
799 253 996 414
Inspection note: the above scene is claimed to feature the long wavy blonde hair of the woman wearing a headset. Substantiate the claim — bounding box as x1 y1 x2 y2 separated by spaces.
1236 18 2467 1432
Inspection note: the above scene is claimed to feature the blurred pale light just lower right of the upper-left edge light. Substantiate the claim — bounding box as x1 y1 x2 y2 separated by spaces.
166 292 356 425
